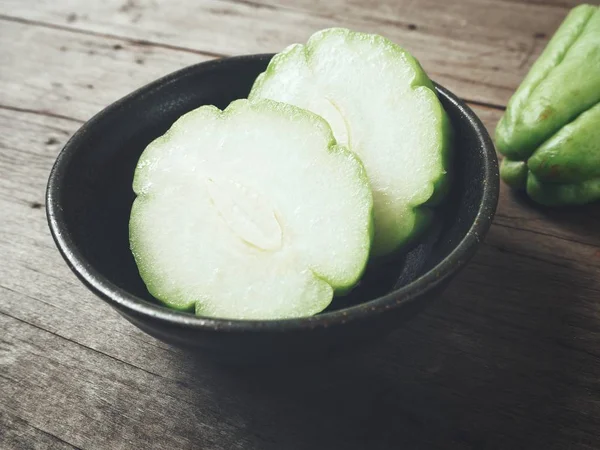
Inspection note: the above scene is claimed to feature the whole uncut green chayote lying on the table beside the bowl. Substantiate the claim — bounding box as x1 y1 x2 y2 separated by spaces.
496 5 600 206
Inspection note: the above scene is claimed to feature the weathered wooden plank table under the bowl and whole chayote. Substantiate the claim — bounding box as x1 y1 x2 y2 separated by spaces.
0 0 600 450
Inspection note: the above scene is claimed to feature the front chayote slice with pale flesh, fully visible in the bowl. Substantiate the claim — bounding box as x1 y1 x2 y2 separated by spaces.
130 100 372 319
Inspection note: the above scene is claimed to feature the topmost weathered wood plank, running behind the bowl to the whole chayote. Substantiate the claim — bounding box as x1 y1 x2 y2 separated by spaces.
0 0 565 105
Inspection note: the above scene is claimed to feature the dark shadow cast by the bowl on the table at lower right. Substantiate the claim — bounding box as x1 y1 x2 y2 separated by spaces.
171 218 600 449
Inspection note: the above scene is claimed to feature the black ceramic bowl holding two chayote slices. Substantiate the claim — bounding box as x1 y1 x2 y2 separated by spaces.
46 55 499 362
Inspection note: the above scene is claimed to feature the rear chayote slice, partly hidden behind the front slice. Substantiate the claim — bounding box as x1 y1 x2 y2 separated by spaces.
249 28 451 256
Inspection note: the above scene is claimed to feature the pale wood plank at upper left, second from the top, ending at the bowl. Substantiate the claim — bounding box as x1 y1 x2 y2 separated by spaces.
0 21 212 121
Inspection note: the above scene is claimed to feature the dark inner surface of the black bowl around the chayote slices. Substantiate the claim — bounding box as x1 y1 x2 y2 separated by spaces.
52 55 495 311
